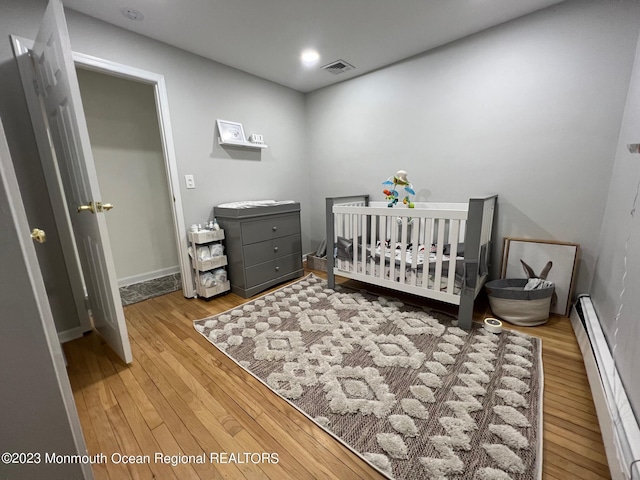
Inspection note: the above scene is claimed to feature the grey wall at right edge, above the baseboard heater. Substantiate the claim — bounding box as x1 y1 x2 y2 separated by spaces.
591 31 640 421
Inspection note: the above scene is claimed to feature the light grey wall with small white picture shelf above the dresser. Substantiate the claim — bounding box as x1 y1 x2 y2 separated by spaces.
65 10 310 240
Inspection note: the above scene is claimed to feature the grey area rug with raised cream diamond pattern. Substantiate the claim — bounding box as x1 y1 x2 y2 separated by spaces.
194 274 543 480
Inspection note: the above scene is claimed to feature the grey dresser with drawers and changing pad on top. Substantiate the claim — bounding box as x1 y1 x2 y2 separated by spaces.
213 203 304 298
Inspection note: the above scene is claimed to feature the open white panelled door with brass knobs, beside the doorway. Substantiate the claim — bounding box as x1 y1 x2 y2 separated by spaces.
25 0 132 363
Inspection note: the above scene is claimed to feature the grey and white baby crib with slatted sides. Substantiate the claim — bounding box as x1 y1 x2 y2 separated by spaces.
326 195 497 329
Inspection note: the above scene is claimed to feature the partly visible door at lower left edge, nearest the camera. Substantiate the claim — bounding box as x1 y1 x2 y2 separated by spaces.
0 122 93 479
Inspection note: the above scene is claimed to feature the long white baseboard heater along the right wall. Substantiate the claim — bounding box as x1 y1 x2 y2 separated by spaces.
570 295 640 480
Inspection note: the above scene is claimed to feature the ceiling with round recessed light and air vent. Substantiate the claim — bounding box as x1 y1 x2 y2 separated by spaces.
63 0 562 92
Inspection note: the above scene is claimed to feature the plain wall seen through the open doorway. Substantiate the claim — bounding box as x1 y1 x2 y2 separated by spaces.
77 69 179 284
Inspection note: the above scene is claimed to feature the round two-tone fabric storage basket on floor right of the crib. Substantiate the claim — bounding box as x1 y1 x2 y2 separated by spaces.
485 278 554 327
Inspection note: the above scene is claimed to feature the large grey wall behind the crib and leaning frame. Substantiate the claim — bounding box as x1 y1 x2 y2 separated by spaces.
308 1 640 291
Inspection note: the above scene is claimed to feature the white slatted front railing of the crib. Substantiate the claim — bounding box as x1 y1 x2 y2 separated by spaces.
332 202 468 303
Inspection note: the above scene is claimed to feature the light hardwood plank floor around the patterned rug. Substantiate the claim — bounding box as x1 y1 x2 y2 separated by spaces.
64 272 610 480
